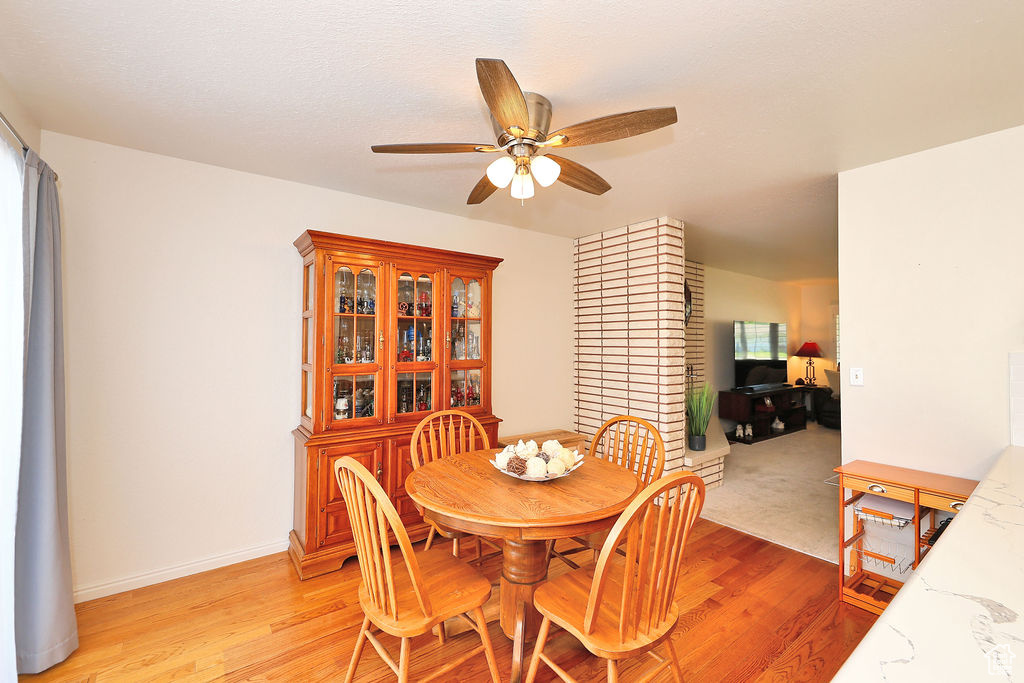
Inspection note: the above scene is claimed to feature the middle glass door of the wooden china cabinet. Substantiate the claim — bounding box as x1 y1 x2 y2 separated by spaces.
390 265 438 419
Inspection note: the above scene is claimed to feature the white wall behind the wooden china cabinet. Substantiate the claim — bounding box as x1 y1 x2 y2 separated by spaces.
43 131 572 599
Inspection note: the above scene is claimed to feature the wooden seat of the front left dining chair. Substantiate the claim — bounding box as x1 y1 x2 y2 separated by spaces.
359 548 490 637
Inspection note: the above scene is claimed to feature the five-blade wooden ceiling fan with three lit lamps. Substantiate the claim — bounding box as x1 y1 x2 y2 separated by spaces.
371 59 677 204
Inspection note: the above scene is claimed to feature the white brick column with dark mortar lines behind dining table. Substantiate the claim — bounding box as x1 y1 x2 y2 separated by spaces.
573 217 685 472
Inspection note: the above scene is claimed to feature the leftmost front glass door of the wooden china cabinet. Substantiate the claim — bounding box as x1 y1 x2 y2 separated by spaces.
327 256 384 426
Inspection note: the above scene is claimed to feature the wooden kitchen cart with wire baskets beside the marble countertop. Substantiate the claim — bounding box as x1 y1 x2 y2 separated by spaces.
835 460 978 614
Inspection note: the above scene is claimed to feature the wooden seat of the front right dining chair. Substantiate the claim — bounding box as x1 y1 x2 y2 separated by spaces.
534 555 679 659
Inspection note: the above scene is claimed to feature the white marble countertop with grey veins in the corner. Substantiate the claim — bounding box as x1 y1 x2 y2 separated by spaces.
833 446 1024 683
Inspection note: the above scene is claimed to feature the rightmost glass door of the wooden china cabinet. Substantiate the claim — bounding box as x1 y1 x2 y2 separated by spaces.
445 274 489 409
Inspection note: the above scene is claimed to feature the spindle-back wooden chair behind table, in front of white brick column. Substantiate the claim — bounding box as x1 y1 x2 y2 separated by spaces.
549 415 665 569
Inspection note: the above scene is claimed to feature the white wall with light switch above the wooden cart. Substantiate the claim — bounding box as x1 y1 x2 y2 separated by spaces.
839 122 1024 478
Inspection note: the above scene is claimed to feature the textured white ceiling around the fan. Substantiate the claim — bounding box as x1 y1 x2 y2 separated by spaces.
0 0 1024 280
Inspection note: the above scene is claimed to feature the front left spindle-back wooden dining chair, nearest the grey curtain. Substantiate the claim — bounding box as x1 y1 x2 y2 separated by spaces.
334 456 498 683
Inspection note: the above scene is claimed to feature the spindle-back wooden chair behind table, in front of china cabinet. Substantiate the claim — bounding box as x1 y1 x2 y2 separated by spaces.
410 411 501 562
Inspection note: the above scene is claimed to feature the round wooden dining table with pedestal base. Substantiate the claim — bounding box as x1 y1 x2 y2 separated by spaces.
406 449 643 683
